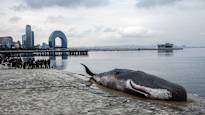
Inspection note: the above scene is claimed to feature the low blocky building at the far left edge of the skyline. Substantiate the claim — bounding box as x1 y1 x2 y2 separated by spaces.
0 36 13 49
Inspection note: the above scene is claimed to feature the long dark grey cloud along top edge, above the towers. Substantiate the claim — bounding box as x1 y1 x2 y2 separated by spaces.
24 0 109 9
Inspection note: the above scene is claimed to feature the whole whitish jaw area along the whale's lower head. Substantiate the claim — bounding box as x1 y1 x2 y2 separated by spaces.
126 80 172 100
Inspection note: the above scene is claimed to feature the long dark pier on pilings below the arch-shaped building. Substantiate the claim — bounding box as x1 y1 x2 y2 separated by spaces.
0 49 88 57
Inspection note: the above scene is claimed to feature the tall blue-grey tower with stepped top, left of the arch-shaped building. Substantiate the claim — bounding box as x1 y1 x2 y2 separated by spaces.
22 25 34 49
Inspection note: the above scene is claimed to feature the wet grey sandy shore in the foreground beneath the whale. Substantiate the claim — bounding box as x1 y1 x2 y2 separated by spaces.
0 68 205 115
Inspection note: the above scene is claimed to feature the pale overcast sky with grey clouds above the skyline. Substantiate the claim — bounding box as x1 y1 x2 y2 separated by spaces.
0 0 205 46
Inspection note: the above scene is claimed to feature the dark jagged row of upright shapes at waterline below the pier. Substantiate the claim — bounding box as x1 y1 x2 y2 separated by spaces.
0 56 51 69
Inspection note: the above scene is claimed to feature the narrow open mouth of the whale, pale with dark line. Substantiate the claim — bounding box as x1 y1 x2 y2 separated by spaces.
129 80 150 97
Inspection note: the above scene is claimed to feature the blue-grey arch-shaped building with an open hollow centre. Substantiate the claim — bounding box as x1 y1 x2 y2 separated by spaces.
49 31 67 49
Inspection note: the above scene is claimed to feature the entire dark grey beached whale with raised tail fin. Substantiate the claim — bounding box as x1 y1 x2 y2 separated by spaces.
82 64 187 101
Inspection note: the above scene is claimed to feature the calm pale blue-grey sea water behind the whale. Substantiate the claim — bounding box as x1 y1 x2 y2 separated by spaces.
52 48 205 97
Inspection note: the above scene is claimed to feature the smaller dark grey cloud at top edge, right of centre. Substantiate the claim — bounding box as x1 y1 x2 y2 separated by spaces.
137 0 181 8
